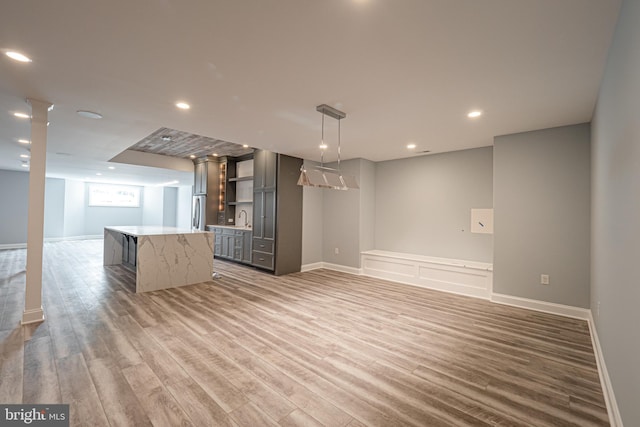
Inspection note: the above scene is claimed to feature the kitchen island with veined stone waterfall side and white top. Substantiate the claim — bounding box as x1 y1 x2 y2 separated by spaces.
103 226 214 292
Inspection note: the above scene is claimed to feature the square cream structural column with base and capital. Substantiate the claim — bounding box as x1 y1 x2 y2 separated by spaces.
22 99 53 325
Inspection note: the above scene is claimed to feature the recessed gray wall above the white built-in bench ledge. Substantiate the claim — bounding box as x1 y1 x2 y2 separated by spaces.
375 147 493 262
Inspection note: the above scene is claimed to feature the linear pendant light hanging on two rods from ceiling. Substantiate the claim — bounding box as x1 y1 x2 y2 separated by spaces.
298 104 360 190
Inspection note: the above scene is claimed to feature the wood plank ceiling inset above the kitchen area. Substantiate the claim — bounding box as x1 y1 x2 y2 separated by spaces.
129 128 253 159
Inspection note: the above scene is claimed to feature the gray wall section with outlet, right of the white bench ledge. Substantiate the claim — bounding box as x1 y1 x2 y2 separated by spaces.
493 124 591 308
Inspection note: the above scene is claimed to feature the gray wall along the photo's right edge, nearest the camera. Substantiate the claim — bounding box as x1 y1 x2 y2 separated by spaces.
591 0 640 426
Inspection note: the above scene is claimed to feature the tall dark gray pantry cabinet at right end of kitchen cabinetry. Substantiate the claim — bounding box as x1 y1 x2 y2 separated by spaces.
251 150 302 275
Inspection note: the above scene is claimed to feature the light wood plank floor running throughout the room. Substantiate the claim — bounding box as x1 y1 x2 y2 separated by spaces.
0 240 608 427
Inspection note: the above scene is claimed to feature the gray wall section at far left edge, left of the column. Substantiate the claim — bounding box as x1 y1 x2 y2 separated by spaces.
0 170 29 245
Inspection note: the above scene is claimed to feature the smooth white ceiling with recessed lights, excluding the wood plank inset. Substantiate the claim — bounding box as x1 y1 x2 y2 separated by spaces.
0 0 620 184
